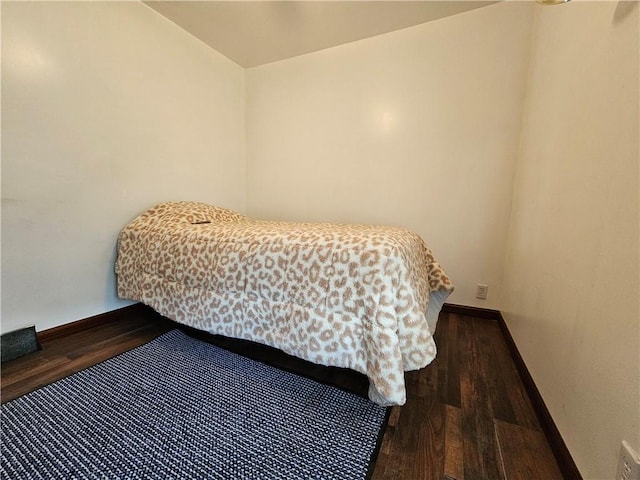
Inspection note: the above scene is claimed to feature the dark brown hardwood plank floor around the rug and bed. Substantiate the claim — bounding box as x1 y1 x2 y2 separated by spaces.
1 309 563 480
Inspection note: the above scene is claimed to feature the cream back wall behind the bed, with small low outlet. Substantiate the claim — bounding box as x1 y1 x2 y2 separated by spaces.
247 2 532 308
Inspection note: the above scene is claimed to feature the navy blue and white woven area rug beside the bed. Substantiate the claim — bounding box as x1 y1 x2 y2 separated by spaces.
0 330 387 480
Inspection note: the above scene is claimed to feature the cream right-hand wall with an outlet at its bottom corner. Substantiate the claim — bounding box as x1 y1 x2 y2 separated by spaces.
501 1 640 480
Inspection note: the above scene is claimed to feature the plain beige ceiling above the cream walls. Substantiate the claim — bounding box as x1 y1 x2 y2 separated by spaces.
144 0 496 67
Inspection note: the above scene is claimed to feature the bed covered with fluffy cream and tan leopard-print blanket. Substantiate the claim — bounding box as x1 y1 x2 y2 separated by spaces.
116 202 453 405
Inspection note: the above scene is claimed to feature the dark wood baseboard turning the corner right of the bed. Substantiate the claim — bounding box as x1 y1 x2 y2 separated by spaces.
442 303 583 480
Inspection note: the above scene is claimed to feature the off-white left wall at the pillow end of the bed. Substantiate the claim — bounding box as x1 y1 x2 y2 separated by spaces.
1 2 246 332
